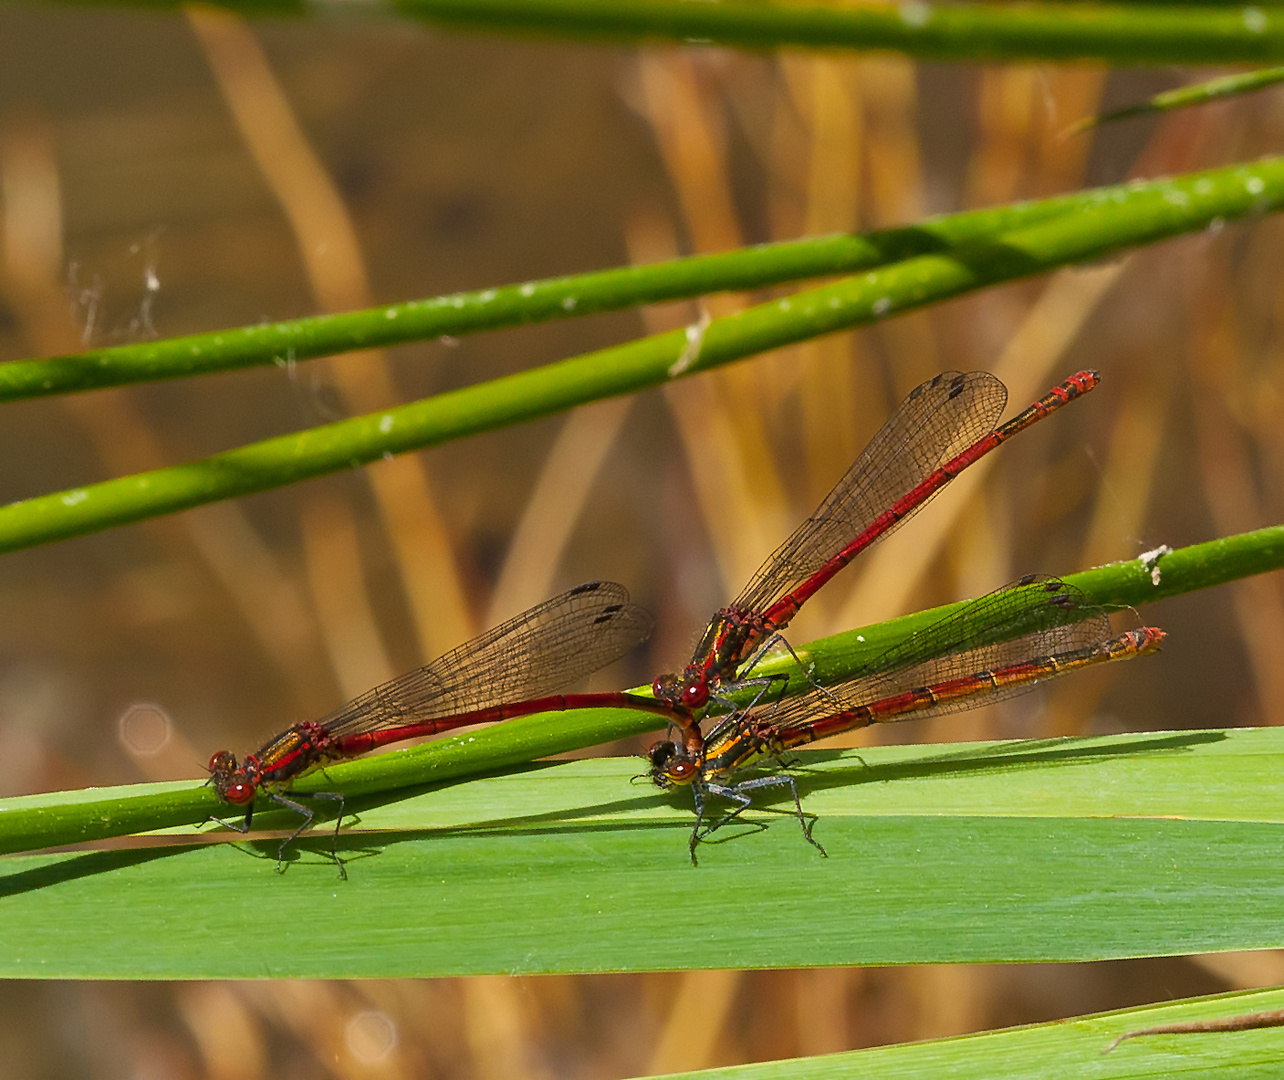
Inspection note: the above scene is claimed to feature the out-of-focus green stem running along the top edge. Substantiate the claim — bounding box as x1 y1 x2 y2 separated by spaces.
112 0 1284 64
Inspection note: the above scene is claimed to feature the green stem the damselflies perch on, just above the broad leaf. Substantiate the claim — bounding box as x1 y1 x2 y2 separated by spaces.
0 527 1284 853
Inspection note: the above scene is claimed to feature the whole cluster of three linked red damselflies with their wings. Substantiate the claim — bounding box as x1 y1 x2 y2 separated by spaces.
209 371 1163 873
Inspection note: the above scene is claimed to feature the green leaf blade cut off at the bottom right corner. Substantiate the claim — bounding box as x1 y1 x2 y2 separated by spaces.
657 989 1284 1080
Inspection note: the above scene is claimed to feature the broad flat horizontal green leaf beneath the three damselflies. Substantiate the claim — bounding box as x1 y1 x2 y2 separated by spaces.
0 729 1284 979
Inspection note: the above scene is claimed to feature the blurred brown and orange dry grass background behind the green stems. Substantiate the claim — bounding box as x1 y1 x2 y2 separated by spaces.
0 9 1284 1080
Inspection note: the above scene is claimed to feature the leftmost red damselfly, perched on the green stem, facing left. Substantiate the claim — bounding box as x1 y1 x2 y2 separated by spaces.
209 582 672 876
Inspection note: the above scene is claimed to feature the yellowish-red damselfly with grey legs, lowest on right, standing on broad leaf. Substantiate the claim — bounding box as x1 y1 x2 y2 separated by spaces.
648 575 1163 863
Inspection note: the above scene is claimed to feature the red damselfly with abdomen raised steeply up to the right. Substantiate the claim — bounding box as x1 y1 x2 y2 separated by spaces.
652 371 1099 756
